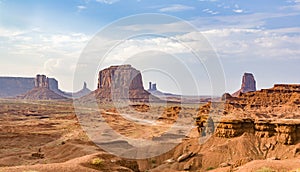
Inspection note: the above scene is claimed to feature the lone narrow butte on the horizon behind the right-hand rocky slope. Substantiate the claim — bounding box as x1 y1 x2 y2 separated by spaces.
232 73 256 97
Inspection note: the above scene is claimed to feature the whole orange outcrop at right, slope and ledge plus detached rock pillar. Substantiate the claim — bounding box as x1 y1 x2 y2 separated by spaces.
196 84 300 144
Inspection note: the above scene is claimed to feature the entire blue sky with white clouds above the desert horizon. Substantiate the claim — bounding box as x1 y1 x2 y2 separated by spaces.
0 0 300 95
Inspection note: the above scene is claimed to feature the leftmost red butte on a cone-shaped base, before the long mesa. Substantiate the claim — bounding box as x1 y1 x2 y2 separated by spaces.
17 75 67 100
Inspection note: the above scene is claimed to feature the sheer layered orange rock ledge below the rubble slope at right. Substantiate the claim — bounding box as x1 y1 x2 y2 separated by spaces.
215 118 300 145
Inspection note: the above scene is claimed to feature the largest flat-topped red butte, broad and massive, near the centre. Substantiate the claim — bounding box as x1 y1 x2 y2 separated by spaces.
90 65 152 102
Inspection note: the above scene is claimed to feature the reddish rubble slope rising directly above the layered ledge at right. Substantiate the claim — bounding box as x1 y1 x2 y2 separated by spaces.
224 84 300 119
